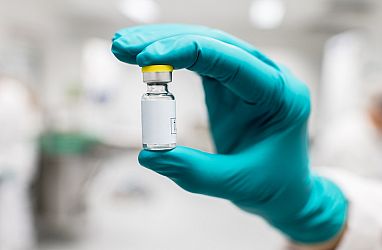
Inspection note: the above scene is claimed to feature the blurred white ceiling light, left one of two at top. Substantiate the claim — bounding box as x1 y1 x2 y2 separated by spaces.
119 0 159 23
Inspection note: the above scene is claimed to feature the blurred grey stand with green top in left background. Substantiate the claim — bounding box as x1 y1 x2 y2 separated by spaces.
34 131 100 240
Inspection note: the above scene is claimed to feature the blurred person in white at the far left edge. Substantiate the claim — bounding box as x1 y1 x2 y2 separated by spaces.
0 77 41 250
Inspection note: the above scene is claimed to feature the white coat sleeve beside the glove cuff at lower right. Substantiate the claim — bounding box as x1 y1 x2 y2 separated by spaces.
318 167 382 250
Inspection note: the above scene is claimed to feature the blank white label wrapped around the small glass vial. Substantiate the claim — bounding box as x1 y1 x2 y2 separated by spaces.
141 100 176 144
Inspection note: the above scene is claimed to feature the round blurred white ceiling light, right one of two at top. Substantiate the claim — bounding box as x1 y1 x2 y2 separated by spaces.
249 0 285 29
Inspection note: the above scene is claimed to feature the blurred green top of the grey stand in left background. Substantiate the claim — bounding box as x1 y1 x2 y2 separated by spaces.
40 131 99 155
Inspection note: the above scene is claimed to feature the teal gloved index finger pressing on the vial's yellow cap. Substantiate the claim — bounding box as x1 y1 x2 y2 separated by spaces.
137 35 283 105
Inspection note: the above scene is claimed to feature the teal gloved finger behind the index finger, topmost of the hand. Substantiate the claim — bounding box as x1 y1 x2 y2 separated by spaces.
112 24 278 69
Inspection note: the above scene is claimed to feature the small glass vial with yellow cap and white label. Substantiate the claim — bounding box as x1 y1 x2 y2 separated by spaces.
141 65 176 150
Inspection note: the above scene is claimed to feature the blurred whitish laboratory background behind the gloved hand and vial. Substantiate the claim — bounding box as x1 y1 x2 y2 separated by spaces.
0 0 382 250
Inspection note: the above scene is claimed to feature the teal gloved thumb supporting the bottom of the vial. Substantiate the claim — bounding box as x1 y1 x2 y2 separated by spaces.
138 146 242 199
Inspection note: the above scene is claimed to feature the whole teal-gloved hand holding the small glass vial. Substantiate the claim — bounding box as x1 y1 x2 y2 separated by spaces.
112 25 347 243
